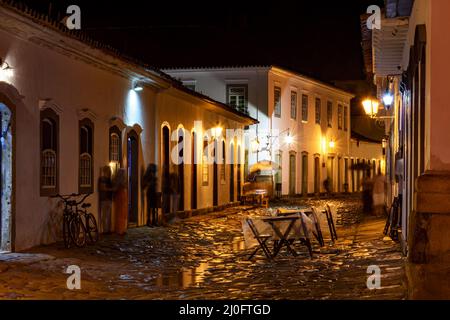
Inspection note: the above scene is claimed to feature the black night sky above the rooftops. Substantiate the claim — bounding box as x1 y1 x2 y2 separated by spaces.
15 0 383 81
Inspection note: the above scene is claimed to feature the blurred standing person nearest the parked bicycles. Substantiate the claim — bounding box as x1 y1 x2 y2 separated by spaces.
98 166 113 233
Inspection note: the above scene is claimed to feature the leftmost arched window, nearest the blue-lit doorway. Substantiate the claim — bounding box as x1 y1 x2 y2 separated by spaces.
40 108 59 196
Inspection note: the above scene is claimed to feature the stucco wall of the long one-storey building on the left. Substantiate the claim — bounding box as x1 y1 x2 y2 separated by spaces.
0 23 246 250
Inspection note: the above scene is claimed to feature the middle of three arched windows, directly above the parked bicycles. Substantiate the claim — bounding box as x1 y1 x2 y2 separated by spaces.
78 119 94 193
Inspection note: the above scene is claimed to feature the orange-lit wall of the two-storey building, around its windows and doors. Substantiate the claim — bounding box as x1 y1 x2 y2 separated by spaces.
268 69 351 194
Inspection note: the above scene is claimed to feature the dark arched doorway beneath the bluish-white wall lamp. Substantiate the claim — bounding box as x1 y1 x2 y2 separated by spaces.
127 131 139 224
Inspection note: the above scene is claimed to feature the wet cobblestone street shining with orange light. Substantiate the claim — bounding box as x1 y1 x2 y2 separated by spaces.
0 199 406 299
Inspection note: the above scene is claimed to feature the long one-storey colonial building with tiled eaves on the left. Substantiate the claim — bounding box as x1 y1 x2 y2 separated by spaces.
0 2 256 251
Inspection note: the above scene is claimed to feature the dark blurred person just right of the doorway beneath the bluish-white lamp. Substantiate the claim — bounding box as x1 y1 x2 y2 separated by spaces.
142 163 159 227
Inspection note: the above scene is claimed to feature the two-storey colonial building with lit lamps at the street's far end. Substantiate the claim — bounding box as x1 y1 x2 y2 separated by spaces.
164 66 370 195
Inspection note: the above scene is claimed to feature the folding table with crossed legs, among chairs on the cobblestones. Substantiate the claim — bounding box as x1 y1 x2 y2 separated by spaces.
261 213 312 258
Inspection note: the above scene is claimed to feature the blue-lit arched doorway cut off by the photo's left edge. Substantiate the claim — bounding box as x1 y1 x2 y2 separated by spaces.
0 103 13 252
